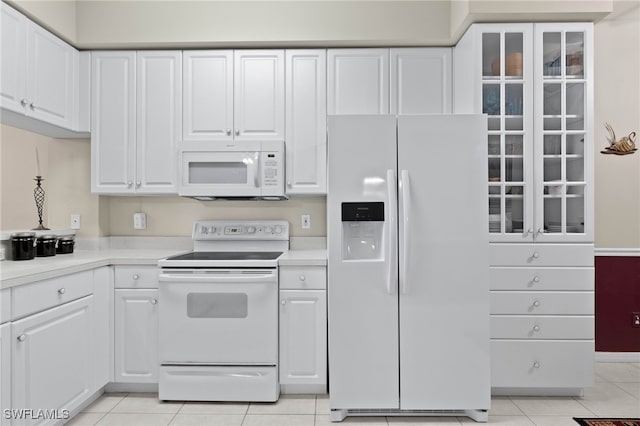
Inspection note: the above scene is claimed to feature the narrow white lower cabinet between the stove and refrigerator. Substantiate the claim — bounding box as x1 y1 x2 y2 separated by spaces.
279 266 327 393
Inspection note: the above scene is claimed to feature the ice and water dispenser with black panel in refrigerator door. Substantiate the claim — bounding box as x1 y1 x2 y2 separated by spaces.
342 202 384 260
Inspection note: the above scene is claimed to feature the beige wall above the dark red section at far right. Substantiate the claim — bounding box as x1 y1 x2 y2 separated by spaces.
594 1 640 248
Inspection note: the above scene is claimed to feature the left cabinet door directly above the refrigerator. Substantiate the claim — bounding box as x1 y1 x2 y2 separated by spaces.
327 49 389 114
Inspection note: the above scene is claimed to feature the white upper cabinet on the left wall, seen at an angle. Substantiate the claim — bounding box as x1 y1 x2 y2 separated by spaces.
1 3 87 131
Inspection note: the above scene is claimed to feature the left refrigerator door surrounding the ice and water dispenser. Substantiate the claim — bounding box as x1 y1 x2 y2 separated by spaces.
327 116 399 409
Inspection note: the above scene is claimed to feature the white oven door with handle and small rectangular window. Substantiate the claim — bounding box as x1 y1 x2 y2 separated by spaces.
159 268 278 365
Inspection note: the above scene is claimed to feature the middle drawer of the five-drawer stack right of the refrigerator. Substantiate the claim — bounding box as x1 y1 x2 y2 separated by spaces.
490 291 594 315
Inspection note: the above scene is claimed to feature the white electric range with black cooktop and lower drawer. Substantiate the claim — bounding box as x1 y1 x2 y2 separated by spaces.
158 221 289 401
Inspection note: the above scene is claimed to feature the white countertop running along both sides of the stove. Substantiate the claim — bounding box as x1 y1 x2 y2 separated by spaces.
0 249 327 288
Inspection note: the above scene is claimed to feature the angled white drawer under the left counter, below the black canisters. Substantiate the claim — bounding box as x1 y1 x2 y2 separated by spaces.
13 270 93 318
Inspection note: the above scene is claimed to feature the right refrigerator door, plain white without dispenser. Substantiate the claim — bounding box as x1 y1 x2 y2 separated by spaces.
398 115 490 410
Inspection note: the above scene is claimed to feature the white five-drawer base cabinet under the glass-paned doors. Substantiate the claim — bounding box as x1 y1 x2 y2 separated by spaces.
489 244 595 395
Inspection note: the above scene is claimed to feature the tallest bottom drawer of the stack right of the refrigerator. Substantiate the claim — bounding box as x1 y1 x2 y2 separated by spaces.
491 340 595 388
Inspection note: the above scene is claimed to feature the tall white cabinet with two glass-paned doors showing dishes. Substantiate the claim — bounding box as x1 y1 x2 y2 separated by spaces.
454 23 593 242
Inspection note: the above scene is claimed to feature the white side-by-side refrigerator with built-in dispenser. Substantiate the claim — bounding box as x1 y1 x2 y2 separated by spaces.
327 115 491 421
